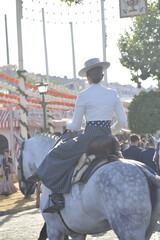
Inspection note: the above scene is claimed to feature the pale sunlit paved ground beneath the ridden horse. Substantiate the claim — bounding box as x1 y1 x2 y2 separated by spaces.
0 209 160 240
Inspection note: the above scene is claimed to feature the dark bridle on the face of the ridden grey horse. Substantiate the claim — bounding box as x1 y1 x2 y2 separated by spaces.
18 141 36 196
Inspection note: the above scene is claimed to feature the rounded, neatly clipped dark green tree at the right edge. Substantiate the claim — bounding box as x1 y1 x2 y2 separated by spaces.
128 91 160 134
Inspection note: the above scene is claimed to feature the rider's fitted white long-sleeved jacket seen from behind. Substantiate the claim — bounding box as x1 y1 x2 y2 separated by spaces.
66 83 127 135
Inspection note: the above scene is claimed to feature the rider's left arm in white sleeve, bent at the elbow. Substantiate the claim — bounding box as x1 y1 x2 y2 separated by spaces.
66 93 85 131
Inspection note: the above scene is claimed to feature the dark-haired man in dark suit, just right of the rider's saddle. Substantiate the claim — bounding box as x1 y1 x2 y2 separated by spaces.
123 134 142 161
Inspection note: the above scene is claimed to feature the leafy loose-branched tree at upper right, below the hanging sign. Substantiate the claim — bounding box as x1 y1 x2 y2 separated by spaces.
118 2 160 88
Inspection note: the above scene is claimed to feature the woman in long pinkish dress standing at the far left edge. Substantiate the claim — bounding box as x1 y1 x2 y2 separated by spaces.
0 149 17 196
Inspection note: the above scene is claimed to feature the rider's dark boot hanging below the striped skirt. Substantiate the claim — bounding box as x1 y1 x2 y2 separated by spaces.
43 193 65 213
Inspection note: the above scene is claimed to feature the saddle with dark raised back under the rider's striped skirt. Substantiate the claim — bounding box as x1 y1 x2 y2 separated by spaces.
71 135 122 184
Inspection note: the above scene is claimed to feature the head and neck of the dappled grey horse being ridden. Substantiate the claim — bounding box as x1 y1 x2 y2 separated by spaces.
15 134 55 196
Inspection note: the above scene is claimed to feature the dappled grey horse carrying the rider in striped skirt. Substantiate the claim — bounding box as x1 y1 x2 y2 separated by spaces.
15 135 160 240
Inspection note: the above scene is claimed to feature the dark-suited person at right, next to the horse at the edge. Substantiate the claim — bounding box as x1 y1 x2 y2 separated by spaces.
140 139 157 172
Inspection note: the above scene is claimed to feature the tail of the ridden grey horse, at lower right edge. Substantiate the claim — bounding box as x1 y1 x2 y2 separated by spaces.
138 168 160 240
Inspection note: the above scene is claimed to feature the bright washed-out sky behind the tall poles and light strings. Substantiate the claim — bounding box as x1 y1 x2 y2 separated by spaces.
0 0 156 86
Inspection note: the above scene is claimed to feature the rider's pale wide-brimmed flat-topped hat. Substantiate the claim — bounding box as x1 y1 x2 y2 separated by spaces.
78 58 110 77
